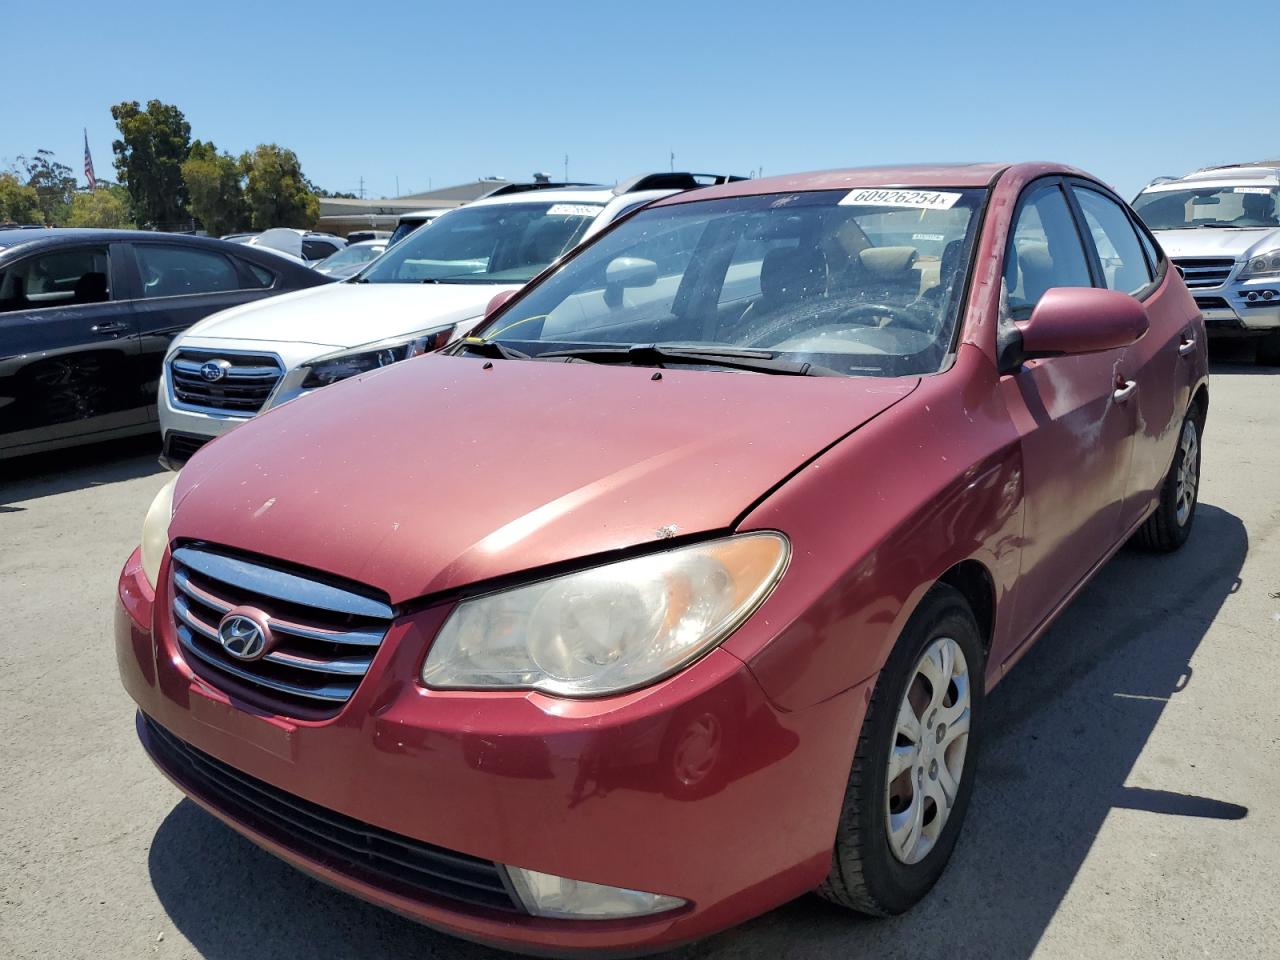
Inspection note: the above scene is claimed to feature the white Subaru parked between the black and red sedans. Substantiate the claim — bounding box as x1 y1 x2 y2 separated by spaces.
157 173 741 468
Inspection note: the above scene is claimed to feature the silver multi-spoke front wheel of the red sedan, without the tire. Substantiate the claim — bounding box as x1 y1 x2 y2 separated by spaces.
884 637 972 864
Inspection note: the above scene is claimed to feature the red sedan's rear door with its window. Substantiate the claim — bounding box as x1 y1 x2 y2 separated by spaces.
1071 180 1197 529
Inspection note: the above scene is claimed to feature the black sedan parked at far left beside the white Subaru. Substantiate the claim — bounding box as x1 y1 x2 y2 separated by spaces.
0 229 330 460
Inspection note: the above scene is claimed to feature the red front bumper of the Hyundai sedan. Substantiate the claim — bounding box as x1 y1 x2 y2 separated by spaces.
115 553 874 955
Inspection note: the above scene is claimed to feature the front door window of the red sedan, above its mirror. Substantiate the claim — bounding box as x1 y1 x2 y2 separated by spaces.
1005 183 1093 320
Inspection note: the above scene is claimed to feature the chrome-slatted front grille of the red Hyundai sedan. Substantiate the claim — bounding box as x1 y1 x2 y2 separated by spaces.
172 544 394 716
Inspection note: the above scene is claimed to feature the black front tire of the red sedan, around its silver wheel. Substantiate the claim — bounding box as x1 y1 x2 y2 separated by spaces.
817 584 986 916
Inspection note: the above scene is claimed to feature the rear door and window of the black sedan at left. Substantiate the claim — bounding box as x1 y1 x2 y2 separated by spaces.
131 239 279 416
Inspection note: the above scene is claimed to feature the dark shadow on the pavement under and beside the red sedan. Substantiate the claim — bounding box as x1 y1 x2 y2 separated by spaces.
150 504 1249 960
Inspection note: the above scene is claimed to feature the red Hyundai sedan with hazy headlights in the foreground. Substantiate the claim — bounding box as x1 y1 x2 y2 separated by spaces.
116 164 1208 954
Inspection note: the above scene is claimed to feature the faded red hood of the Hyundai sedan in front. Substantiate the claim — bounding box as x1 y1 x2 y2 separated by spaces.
170 355 919 603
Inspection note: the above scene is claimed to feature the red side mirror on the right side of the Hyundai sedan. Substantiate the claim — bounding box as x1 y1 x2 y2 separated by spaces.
1002 287 1151 366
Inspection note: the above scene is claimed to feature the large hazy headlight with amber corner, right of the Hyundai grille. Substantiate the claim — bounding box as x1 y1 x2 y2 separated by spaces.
422 532 790 696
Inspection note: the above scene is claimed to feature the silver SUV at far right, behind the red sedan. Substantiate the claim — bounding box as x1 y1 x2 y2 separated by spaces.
1133 160 1280 365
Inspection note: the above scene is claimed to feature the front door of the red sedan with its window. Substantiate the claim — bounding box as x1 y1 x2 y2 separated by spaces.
993 178 1137 659
